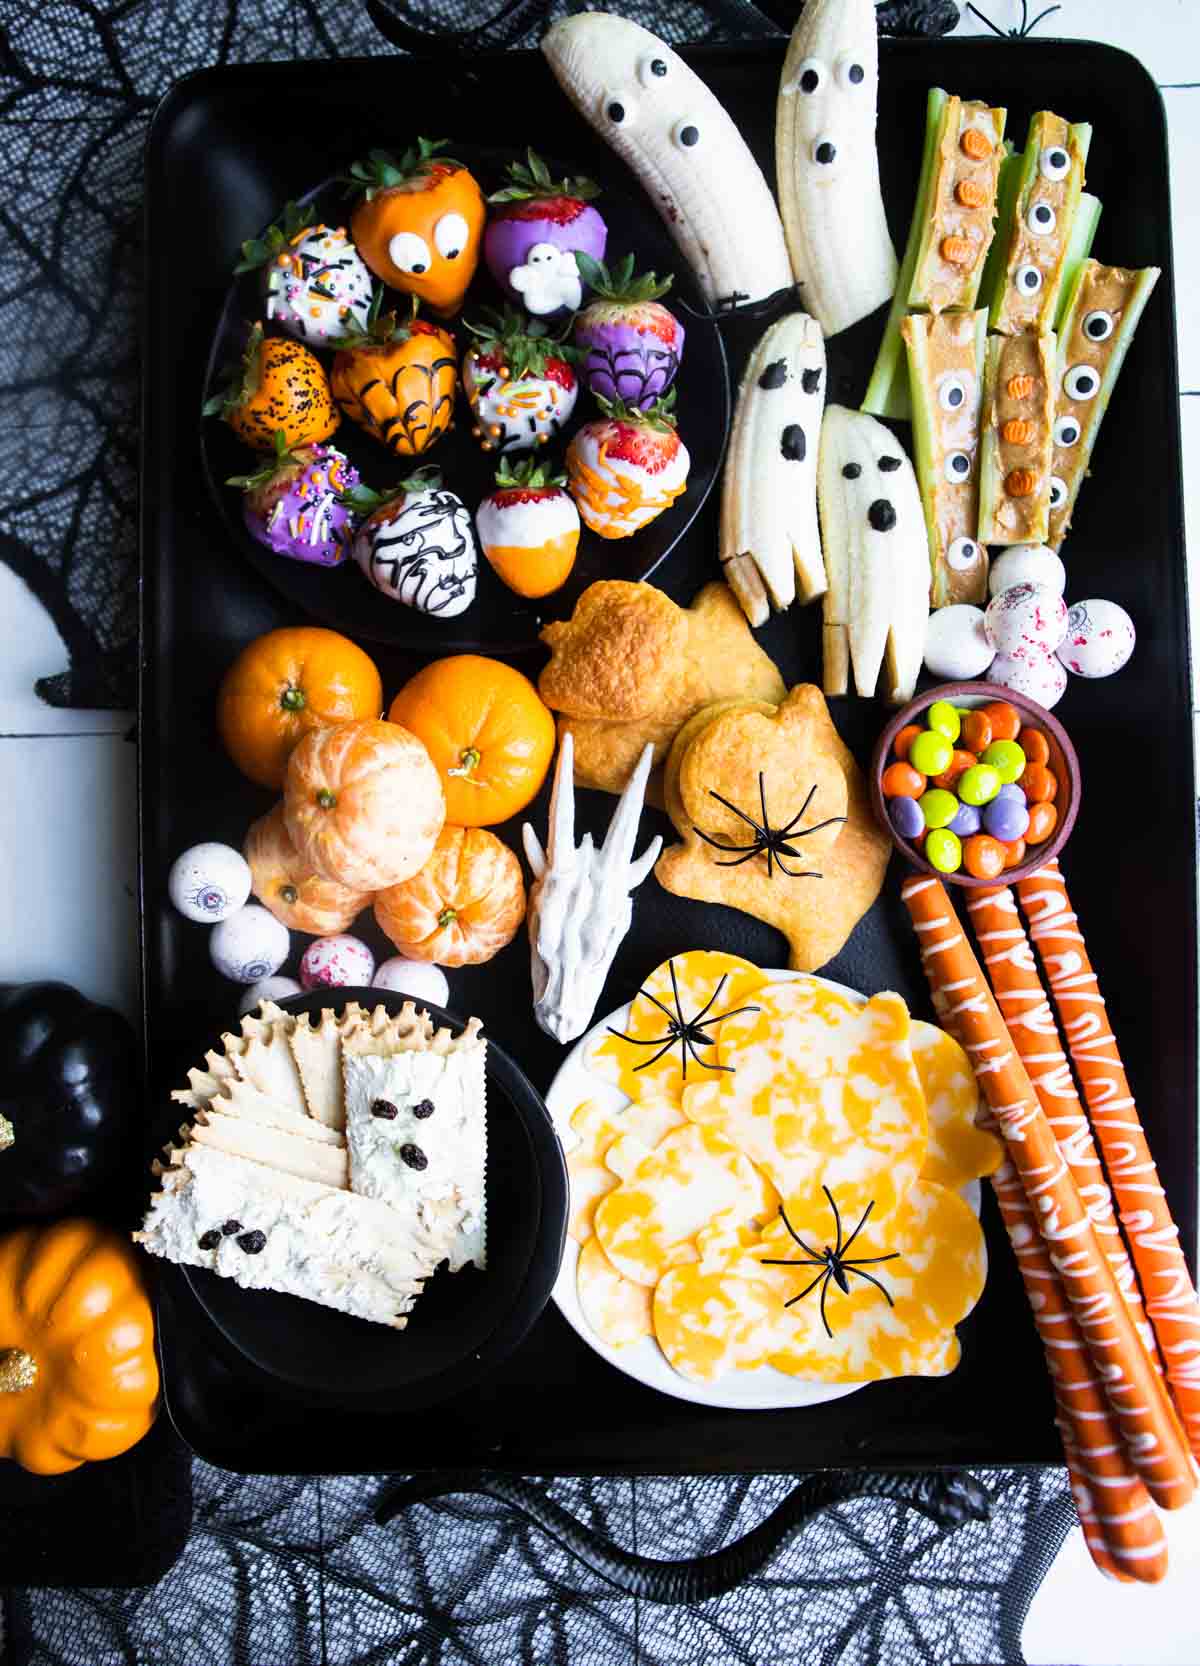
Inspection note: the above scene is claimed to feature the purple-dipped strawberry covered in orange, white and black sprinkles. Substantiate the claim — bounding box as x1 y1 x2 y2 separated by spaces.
225 433 358 566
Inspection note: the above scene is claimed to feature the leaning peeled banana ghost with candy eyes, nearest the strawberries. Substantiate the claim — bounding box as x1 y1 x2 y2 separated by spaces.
542 13 793 308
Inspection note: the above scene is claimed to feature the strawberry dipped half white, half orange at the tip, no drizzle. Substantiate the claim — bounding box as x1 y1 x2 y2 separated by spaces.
475 456 580 596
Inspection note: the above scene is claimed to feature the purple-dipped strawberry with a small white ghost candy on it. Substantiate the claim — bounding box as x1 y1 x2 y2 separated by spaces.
483 150 608 318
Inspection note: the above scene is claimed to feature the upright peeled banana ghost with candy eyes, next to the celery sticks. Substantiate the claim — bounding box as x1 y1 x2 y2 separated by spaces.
775 0 897 337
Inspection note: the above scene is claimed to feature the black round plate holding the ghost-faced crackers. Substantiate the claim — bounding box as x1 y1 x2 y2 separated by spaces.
183 990 567 1406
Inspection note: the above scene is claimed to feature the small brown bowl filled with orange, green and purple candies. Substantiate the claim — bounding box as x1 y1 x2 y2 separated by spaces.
880 700 1058 880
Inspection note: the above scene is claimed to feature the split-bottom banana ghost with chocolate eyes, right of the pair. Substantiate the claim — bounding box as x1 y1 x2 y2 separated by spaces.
817 414 930 706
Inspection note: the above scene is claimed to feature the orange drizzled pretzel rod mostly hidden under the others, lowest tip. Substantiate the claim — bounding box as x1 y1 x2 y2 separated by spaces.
922 926 1167 1584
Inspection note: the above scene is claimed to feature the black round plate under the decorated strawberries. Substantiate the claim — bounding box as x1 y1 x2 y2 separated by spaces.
200 145 730 653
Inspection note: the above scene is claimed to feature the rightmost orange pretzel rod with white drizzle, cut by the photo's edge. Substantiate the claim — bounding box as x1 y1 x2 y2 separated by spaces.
1017 861 1200 1454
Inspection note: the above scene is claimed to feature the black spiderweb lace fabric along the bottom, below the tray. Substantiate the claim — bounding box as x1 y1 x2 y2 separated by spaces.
10 1463 1072 1666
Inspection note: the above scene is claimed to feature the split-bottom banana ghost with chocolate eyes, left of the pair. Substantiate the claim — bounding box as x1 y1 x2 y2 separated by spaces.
720 313 825 625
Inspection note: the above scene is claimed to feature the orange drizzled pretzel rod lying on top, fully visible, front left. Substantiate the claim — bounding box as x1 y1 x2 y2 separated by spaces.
900 875 1195 1509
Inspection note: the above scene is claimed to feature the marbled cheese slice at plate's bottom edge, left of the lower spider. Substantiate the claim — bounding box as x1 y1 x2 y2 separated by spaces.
653 1211 787 1383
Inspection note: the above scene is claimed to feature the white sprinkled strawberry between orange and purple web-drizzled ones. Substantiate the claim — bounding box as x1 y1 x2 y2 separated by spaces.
462 307 578 451
